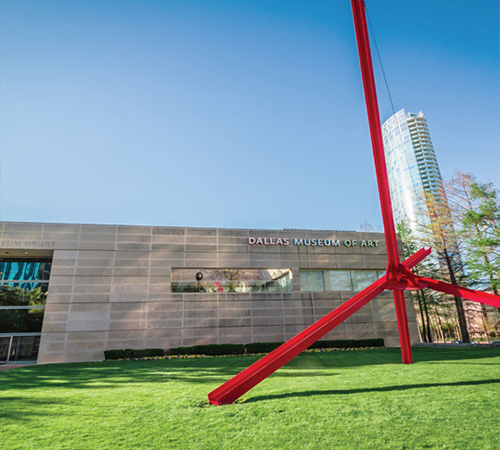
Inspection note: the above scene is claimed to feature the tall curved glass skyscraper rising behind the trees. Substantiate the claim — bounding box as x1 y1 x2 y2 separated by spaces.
382 109 442 235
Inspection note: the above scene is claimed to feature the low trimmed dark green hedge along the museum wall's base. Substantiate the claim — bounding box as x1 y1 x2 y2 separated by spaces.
104 338 384 359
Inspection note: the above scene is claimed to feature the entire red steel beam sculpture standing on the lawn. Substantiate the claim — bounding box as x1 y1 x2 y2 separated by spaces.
208 0 500 405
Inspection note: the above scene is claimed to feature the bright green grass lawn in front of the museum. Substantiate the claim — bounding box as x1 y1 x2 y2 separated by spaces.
0 348 500 450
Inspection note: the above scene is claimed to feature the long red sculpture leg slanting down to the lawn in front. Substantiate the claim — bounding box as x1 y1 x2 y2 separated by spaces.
208 276 385 405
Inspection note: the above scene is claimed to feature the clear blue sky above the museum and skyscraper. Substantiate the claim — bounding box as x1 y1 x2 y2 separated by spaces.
0 0 500 230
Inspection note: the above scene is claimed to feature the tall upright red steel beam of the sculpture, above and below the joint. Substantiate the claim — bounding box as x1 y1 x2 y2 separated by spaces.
351 0 412 364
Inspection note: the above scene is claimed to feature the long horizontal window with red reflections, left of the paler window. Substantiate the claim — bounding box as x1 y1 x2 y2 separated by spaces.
171 269 293 293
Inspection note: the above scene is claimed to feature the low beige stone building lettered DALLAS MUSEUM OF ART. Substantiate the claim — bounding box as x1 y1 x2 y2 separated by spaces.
0 222 418 363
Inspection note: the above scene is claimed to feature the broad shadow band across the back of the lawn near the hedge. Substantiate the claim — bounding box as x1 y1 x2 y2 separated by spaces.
0 348 500 391
